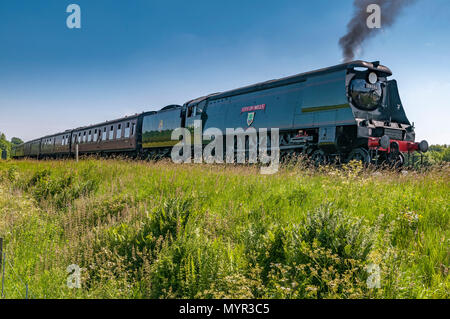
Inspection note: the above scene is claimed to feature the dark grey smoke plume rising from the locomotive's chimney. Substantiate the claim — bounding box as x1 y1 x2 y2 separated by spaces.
339 0 416 62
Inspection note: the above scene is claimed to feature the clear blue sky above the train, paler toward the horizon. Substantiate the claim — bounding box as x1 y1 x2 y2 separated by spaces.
0 0 450 144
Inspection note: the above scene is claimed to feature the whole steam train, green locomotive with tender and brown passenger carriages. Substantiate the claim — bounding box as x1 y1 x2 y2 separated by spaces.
12 61 428 165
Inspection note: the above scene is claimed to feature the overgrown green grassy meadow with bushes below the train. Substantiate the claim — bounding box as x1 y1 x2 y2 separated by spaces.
0 159 450 298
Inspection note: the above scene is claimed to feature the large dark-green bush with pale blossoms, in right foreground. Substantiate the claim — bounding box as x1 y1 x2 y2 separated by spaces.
258 206 373 298
